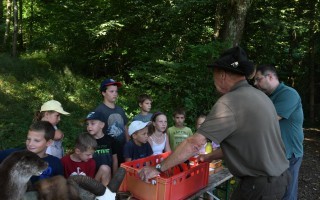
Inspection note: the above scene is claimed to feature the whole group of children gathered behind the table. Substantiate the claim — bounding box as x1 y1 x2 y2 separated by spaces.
0 79 218 189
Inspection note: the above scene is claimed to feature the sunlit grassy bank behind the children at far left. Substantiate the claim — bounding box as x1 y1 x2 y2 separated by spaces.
0 54 109 149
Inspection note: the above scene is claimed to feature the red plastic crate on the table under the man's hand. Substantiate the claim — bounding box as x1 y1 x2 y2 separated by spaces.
119 153 209 200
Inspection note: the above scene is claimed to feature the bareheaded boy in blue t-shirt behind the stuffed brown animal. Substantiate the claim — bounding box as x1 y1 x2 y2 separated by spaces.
0 121 63 183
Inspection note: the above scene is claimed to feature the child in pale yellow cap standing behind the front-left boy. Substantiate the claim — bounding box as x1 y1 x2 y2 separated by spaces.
34 100 70 158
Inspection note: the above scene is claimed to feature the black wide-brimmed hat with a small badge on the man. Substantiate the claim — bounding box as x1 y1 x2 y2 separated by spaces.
208 46 254 76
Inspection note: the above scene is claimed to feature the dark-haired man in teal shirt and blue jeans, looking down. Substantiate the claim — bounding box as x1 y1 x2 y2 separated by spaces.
255 64 304 200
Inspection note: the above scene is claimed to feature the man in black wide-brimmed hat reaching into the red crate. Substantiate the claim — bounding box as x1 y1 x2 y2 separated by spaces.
139 47 289 200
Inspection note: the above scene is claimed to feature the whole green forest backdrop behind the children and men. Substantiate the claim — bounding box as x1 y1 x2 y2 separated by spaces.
0 0 320 149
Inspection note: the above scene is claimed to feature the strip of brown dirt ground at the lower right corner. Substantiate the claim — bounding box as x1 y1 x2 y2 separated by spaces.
299 129 320 200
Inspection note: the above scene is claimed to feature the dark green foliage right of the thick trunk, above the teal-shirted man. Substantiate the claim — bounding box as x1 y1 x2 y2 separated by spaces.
243 0 320 124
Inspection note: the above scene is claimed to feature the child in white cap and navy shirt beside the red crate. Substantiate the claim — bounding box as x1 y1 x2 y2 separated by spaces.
123 121 153 162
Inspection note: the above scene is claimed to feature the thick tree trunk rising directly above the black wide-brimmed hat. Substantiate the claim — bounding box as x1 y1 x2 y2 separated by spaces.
221 0 253 46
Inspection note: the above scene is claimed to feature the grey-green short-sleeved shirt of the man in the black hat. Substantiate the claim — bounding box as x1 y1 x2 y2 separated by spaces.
197 80 289 177
